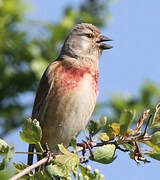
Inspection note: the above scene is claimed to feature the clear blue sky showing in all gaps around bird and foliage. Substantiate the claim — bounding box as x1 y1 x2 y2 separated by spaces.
7 0 160 180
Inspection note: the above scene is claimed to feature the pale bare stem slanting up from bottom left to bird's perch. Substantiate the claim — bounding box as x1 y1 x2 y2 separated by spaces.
9 156 50 180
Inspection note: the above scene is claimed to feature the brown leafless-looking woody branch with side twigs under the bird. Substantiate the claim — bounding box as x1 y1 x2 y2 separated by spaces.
9 110 152 180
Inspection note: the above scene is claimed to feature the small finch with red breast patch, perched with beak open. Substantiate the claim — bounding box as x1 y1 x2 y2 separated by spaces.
28 23 112 165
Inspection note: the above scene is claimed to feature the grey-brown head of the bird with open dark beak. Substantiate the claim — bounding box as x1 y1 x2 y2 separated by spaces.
61 23 112 59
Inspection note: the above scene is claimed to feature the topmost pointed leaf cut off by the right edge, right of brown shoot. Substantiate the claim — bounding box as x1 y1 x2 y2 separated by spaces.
151 103 160 128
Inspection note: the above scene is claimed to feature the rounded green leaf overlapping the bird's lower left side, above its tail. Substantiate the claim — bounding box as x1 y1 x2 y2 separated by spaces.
20 118 42 144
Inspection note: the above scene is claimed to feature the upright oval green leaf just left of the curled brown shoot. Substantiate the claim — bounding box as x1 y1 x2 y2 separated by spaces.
120 111 133 135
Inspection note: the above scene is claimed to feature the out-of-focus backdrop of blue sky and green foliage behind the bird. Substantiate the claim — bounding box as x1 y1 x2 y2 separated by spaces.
0 0 160 180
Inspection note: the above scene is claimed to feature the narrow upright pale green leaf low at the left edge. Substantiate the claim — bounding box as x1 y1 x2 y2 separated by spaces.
0 147 15 170
